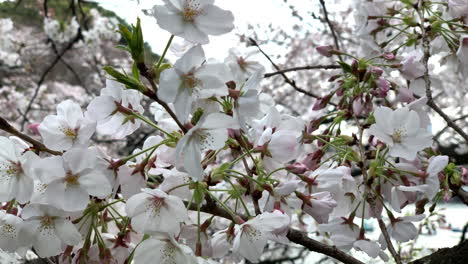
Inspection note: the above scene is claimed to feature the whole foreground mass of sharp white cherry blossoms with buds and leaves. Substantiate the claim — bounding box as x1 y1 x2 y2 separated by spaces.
0 0 468 264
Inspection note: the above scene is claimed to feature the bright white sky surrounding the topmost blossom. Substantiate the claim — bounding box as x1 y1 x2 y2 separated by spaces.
96 0 311 60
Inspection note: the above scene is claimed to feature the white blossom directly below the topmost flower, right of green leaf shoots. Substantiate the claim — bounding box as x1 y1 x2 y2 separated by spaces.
158 45 228 122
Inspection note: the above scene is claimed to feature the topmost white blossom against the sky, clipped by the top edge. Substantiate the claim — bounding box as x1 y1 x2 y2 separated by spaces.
153 0 234 44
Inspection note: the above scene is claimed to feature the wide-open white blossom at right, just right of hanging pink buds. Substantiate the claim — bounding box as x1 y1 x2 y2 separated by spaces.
369 107 432 160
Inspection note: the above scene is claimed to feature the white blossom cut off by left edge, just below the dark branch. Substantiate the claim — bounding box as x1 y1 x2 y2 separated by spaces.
0 137 38 203
